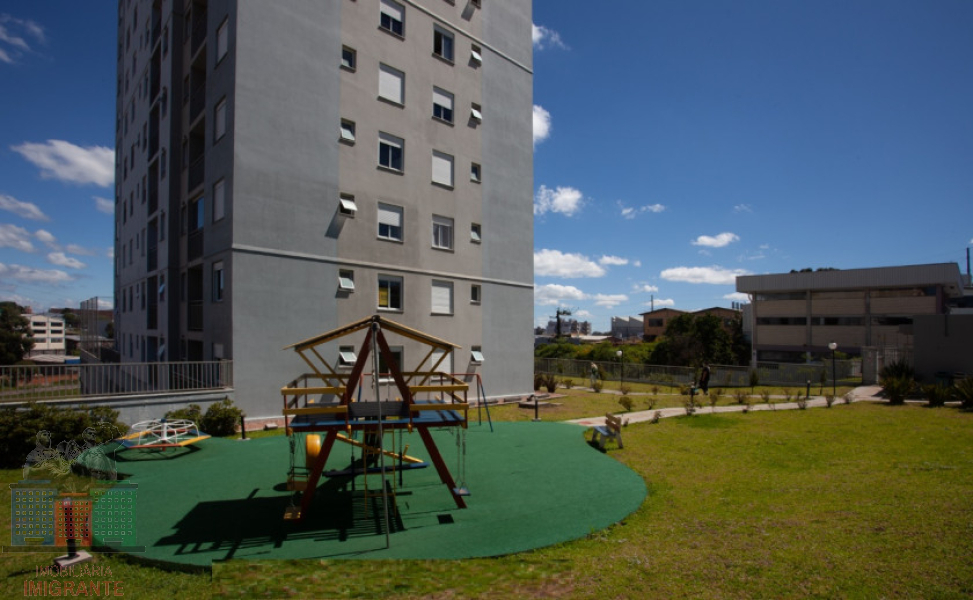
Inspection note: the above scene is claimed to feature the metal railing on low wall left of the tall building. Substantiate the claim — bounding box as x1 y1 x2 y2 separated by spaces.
0 360 233 402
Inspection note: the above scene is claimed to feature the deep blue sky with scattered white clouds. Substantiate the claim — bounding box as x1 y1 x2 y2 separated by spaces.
0 0 973 330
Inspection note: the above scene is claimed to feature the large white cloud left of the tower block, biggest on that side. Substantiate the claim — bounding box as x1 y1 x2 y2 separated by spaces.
10 140 115 187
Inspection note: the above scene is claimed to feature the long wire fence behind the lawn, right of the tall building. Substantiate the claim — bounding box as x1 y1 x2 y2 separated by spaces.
534 358 861 387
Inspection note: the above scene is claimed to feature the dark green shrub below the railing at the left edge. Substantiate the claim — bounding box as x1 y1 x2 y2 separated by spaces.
0 402 128 469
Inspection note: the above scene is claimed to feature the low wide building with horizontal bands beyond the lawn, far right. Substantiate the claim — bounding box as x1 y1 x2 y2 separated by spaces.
736 263 963 361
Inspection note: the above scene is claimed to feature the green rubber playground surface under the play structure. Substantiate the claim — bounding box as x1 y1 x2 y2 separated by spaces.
102 422 646 566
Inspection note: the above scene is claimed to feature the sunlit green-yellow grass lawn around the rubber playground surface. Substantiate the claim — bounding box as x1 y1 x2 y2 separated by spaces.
0 395 973 599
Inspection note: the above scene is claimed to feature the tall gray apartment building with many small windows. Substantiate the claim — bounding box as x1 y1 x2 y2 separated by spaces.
115 0 533 418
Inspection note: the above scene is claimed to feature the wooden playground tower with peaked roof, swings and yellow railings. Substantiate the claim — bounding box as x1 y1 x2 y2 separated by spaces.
281 315 474 521
